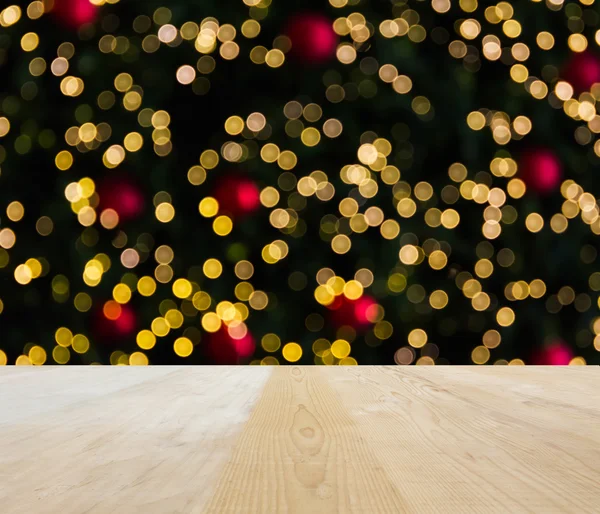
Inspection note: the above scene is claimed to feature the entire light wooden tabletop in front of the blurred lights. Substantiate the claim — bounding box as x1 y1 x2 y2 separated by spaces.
0 367 600 514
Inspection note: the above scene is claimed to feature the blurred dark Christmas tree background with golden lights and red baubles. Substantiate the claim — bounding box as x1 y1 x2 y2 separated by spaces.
0 0 600 365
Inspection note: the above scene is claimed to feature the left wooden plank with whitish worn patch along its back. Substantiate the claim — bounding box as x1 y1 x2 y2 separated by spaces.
0 367 271 514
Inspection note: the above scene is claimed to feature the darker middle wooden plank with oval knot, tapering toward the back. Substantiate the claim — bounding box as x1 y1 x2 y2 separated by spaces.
207 367 405 513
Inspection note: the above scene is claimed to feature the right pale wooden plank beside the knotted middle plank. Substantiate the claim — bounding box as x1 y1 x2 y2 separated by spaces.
332 367 600 513
